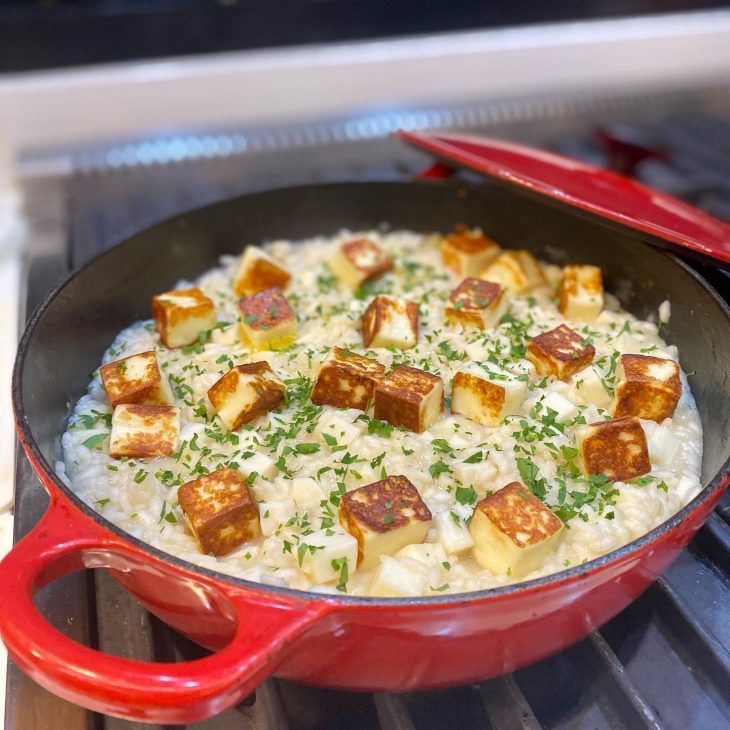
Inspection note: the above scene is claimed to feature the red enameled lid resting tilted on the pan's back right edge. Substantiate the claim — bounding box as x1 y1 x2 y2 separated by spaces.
398 131 730 268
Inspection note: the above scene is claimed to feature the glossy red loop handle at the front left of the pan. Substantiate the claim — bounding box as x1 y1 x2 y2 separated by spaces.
0 490 332 724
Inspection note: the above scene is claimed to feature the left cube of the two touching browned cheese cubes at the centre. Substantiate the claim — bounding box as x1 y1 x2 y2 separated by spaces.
312 347 385 411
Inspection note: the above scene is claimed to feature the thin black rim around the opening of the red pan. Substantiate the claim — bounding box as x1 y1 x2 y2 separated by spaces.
12 180 730 608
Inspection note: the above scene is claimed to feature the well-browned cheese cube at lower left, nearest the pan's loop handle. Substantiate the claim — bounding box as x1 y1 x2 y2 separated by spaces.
177 469 261 555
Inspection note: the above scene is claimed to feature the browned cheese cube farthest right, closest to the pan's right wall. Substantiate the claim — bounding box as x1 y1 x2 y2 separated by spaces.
612 355 682 423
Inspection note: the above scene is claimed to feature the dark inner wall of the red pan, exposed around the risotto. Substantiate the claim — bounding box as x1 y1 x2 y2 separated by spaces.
15 182 730 544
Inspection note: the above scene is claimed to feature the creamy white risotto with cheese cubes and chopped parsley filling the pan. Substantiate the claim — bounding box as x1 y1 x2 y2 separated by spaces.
58 231 702 596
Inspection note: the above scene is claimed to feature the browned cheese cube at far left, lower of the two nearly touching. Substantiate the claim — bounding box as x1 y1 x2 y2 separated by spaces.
109 403 180 459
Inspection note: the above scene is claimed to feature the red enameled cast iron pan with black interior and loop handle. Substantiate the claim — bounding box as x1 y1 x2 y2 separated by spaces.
0 144 730 723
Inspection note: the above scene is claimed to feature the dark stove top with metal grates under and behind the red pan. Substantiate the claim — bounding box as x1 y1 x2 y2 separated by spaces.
6 90 730 730
